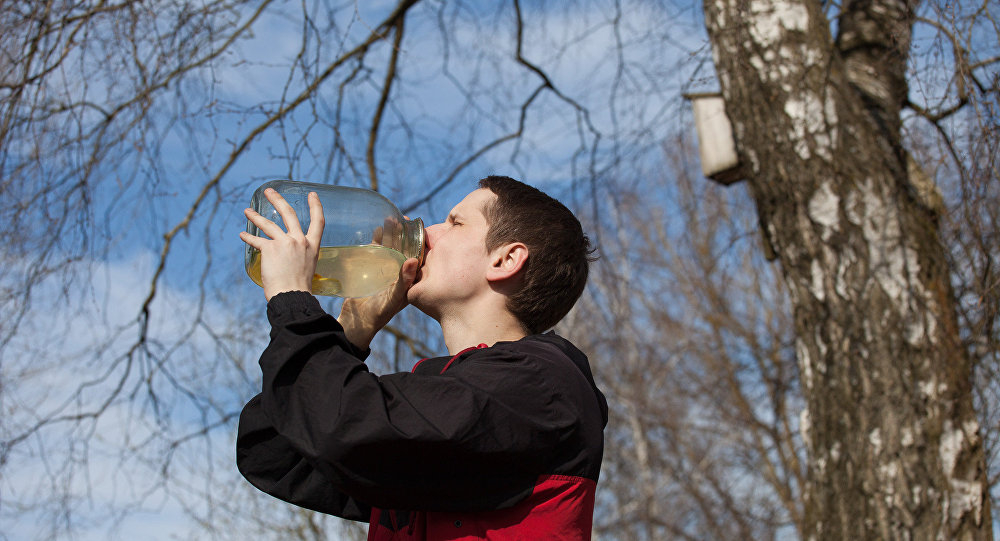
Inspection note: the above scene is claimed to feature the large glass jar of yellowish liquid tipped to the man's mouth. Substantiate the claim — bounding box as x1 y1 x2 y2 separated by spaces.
245 180 424 297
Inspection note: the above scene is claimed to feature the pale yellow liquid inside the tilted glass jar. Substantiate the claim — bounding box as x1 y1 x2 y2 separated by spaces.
247 245 406 297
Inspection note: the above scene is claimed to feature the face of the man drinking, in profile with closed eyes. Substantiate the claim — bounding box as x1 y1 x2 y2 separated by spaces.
407 188 496 321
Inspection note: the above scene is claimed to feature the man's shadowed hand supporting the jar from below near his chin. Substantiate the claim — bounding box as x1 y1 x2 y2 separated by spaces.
337 257 420 350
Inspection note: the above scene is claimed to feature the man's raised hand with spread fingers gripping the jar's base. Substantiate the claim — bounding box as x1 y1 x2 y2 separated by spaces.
240 188 326 300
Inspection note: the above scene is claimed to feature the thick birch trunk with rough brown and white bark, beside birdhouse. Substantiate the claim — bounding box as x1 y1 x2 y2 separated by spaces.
704 0 992 540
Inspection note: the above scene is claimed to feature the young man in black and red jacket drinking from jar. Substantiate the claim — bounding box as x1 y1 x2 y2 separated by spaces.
237 177 608 540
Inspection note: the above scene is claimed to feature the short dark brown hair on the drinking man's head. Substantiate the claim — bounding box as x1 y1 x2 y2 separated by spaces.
479 176 593 334
